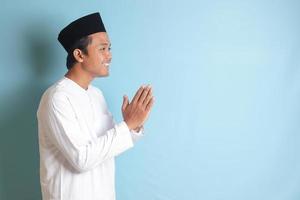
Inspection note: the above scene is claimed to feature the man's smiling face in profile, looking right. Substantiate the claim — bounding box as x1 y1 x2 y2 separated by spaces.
82 32 112 77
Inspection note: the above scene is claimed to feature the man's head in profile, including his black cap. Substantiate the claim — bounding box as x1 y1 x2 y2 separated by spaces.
58 13 112 77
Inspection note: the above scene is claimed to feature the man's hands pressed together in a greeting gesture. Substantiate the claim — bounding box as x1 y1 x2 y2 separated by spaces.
122 86 154 130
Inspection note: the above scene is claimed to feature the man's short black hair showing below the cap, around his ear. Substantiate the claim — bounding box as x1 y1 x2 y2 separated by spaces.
66 36 92 69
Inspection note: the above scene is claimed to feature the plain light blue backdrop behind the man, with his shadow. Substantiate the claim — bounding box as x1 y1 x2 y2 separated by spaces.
0 0 300 200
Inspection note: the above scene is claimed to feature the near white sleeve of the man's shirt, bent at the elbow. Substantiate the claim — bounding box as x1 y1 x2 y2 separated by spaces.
42 95 133 172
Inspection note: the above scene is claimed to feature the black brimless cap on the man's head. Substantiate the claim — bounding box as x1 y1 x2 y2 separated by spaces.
57 12 106 52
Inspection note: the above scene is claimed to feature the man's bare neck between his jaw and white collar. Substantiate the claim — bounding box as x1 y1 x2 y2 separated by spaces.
65 66 93 90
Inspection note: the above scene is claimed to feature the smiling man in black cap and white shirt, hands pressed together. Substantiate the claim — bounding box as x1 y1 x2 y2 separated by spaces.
37 13 154 200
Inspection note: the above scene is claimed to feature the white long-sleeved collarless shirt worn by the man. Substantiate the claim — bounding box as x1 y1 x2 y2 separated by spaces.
37 77 143 200
